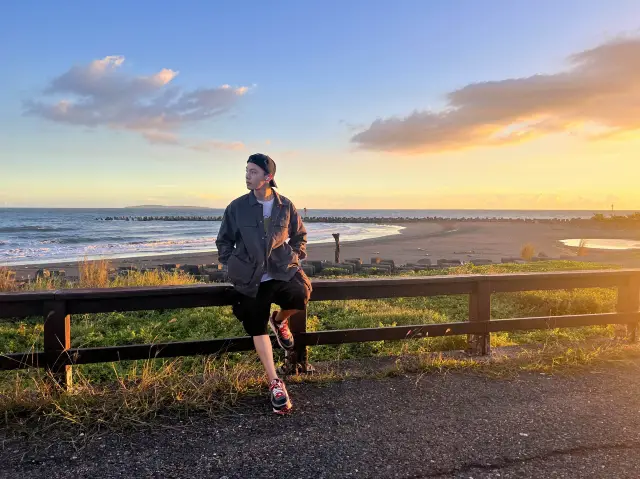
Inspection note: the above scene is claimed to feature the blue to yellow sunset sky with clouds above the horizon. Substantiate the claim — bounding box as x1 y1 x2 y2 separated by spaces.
0 0 640 210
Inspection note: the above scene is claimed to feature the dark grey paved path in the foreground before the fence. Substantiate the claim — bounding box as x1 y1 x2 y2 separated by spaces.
0 362 640 479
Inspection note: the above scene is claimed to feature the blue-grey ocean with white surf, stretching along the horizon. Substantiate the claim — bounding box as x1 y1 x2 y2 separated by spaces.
0 208 631 266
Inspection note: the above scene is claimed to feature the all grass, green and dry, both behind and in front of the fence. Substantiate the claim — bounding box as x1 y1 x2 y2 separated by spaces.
0 261 640 434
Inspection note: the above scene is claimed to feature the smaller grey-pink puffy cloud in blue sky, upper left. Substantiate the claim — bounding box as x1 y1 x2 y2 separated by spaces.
25 56 248 144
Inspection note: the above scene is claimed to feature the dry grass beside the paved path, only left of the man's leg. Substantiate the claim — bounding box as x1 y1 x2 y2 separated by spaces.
0 357 266 429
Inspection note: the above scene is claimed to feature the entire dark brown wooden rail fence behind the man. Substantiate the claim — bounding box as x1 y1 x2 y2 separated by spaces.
0 269 640 387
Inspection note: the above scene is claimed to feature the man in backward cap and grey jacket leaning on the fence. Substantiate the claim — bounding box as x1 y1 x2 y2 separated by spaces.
216 153 311 414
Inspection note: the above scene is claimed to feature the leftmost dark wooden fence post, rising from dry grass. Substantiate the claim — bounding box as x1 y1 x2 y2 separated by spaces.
44 301 73 389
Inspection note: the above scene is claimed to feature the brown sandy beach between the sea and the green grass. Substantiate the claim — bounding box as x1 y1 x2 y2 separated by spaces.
6 221 640 278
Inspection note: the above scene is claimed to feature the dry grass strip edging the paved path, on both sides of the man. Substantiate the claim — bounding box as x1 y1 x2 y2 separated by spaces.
0 341 640 431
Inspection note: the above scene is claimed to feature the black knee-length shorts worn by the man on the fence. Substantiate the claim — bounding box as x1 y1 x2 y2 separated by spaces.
233 271 311 336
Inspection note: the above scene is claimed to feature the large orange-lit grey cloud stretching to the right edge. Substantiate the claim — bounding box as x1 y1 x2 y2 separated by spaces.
351 38 640 154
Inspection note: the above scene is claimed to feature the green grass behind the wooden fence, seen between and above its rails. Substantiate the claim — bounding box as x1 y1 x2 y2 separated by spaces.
0 261 616 380
